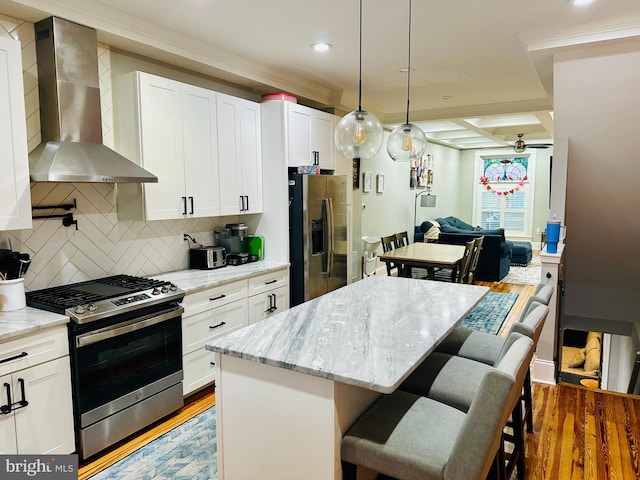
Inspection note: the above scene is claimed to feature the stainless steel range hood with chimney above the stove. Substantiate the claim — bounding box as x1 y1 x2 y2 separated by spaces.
29 17 158 183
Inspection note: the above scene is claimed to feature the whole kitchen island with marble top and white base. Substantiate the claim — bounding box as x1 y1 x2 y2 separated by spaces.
206 276 489 480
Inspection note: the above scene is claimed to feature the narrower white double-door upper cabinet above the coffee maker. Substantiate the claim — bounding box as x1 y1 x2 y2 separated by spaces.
217 93 263 215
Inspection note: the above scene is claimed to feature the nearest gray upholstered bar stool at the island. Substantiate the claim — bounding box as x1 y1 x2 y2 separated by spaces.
341 336 533 480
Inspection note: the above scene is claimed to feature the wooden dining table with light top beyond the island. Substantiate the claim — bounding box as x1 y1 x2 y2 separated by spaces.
378 242 465 282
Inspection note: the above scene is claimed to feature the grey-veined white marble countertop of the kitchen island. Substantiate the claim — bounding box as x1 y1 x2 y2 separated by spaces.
206 275 489 393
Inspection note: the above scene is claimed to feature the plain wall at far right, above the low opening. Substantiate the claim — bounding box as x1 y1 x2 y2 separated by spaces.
554 40 640 328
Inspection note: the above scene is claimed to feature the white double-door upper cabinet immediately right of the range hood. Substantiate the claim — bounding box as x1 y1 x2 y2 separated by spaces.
114 72 220 220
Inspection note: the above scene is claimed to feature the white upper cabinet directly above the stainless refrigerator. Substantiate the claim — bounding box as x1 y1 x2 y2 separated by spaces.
285 102 336 170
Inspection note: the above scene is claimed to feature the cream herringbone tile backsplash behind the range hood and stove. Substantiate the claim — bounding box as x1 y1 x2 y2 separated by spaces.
0 15 238 290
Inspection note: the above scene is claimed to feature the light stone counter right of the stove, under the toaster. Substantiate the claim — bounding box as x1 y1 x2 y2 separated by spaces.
151 260 289 293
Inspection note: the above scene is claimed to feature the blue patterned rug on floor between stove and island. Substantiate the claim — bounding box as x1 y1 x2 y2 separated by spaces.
91 406 218 480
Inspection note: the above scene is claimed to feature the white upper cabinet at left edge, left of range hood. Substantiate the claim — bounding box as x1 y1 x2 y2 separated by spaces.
0 37 31 231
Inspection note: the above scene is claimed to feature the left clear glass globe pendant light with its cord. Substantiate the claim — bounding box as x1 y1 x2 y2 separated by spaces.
335 0 384 158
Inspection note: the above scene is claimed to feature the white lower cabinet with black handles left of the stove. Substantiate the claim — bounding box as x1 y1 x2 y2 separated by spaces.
0 326 76 454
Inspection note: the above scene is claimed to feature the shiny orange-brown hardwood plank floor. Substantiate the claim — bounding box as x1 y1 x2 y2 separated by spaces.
78 282 640 480
